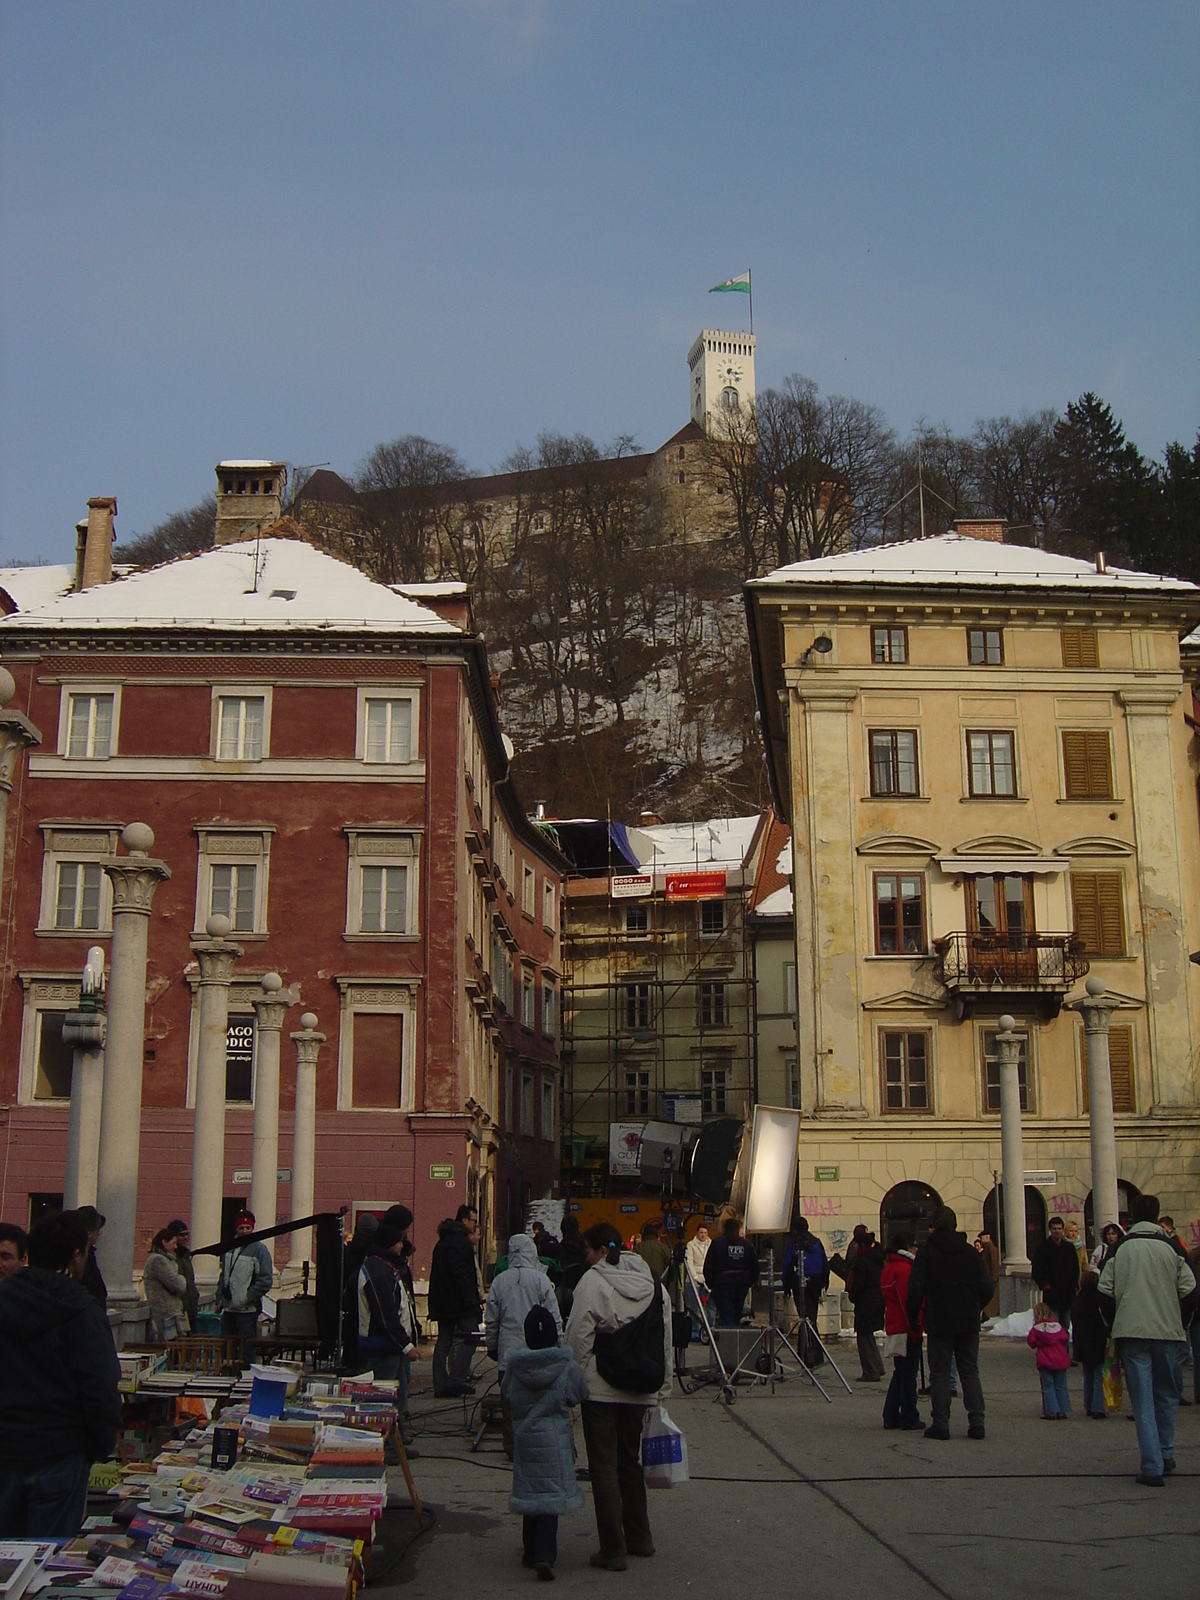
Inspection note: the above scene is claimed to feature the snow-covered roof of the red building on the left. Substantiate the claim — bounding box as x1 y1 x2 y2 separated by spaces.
0 538 461 635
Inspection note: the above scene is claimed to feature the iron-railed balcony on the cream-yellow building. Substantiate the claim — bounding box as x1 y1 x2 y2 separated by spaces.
933 933 1088 1018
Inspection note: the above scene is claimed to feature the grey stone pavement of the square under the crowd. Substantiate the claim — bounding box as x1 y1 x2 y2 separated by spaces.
371 1341 1200 1600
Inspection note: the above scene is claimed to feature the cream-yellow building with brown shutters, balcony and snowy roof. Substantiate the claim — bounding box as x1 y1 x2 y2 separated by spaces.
747 523 1200 1242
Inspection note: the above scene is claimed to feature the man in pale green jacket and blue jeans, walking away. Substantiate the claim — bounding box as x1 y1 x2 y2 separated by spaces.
1099 1195 1195 1490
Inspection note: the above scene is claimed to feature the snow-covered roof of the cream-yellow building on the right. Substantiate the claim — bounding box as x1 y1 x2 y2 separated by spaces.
749 533 1200 597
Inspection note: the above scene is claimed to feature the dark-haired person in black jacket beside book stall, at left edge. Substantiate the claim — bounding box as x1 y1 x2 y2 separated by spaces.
0 1211 122 1539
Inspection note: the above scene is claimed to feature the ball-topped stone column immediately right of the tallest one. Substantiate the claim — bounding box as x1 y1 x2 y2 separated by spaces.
189 915 243 1285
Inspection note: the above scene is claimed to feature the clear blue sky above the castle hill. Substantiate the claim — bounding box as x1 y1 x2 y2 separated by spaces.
0 0 1200 560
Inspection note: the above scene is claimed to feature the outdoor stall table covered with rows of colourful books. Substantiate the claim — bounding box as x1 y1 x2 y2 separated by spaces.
0 1363 424 1600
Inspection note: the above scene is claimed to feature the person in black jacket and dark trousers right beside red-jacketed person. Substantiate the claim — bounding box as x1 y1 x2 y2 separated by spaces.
904 1205 995 1438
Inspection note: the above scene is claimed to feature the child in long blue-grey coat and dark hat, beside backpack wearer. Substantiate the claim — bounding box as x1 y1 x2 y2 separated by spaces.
501 1306 587 1578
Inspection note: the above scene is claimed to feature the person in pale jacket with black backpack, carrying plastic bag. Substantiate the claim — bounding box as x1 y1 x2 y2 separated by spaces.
566 1222 670 1573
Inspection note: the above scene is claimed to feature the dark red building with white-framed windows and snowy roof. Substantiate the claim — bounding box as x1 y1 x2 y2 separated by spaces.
0 536 562 1275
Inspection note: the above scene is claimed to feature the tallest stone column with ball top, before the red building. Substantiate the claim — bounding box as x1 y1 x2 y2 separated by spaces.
96 822 171 1314
